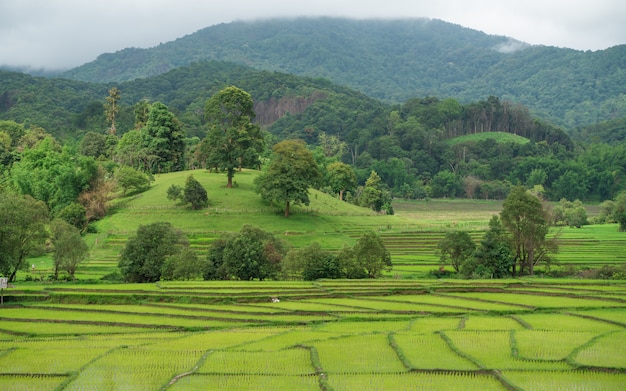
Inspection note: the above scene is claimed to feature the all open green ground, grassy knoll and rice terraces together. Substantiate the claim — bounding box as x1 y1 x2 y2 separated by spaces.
0 170 626 391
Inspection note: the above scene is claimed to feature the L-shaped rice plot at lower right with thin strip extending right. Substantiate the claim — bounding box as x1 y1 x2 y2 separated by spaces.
445 331 571 370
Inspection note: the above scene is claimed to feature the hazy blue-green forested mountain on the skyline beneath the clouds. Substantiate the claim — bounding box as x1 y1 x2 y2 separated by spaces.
63 18 626 128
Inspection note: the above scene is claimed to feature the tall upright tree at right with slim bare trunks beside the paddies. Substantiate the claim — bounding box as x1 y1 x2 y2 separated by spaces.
500 186 556 276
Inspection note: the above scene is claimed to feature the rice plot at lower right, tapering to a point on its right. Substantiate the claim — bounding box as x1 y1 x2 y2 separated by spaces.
515 330 597 361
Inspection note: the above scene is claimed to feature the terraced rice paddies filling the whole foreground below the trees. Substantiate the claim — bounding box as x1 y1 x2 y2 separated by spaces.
0 280 626 391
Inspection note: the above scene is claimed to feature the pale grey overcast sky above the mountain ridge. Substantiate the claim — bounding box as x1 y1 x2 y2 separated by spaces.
0 0 626 69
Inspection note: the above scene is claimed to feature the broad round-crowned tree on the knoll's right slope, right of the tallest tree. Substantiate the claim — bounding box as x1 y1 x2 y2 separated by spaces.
254 140 320 217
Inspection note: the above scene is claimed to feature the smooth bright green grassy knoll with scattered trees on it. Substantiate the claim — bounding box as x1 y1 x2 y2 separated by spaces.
96 170 400 248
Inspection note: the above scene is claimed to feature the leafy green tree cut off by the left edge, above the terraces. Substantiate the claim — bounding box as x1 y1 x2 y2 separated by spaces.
0 192 49 281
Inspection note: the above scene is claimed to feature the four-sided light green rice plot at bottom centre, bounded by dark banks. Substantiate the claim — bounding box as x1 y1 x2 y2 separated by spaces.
312 334 405 373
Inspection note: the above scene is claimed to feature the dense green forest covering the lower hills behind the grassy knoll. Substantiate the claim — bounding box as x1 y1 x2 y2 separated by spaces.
0 57 626 216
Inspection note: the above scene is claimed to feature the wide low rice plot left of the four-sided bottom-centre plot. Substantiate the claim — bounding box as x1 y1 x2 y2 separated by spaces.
198 348 315 375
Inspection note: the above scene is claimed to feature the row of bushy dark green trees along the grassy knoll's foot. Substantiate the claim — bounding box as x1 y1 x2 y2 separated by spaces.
117 222 392 282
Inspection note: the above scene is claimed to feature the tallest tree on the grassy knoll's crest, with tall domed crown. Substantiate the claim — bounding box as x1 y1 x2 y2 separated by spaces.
204 86 264 188
